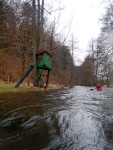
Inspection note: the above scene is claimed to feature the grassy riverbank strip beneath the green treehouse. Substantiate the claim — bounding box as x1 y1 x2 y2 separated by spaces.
0 83 63 93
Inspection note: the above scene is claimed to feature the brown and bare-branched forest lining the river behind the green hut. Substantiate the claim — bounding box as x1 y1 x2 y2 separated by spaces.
0 0 113 86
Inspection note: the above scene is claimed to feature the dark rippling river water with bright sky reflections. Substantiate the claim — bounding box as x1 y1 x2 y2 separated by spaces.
0 86 113 150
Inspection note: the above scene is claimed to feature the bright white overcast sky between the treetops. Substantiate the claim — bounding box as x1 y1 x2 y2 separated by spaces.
46 0 104 63
